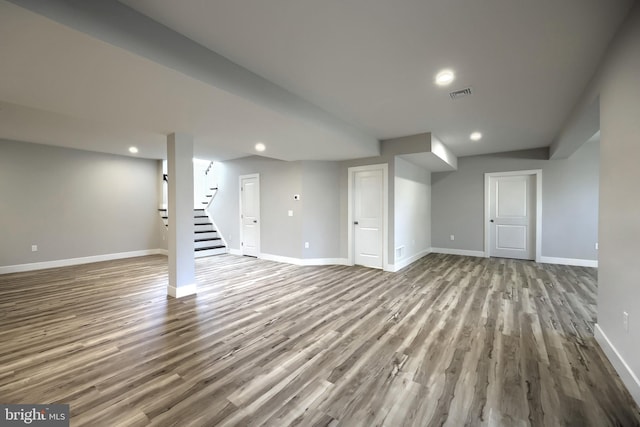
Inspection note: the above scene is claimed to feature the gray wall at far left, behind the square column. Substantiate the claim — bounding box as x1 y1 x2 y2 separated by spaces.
0 141 162 266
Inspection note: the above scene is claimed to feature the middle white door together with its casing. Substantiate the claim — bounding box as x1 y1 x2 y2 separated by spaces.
348 164 388 269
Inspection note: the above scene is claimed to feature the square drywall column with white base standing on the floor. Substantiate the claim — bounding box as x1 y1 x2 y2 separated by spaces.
167 133 196 298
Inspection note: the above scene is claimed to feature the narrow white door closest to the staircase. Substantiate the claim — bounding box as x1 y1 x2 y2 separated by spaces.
240 175 260 257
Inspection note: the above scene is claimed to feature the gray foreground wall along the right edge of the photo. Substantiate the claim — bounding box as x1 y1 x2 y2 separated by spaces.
598 3 640 404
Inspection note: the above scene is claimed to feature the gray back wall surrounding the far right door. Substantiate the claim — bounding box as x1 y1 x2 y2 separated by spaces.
431 143 599 260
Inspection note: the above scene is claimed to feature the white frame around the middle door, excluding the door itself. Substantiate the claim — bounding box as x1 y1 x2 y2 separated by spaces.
347 163 389 271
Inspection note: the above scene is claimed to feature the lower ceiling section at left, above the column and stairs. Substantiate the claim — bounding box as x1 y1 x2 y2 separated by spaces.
0 2 377 160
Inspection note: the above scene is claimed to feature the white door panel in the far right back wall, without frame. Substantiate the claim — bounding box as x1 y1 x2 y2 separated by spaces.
489 175 536 259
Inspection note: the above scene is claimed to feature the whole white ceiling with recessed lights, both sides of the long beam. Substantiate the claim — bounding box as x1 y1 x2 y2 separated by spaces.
0 0 633 160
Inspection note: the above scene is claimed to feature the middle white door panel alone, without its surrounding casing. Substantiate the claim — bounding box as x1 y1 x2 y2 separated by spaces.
353 169 383 268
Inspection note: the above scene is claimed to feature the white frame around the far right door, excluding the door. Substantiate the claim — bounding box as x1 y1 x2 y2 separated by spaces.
484 169 542 262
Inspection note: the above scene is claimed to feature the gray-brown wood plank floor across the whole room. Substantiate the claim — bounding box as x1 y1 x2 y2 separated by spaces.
0 254 640 426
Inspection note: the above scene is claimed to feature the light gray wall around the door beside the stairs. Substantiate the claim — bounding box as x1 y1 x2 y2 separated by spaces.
210 156 340 259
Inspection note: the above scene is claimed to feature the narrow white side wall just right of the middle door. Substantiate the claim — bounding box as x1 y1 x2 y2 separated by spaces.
394 157 431 268
